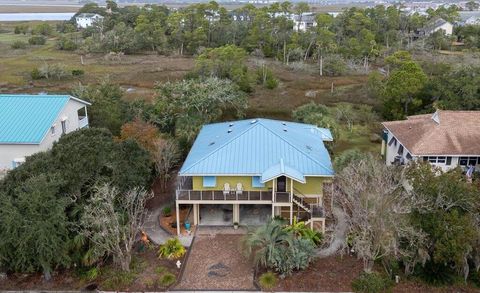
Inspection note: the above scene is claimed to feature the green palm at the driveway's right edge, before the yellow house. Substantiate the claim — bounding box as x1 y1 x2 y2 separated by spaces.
244 219 293 267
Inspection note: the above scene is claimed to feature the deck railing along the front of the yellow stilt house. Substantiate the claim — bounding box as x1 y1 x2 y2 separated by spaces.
176 189 291 203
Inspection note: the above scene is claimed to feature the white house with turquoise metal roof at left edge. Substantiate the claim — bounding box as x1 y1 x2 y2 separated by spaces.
0 95 90 173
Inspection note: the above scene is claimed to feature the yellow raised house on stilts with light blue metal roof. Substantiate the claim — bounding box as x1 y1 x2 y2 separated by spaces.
176 119 334 234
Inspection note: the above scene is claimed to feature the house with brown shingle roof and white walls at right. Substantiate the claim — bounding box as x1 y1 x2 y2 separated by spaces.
382 110 480 171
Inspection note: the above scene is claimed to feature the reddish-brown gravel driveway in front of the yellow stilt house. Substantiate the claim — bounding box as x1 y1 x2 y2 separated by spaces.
175 234 256 290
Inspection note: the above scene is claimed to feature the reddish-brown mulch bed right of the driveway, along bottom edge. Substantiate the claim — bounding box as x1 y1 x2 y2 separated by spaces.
270 255 363 292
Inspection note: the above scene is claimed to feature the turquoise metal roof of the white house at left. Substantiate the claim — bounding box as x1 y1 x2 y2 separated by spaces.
0 95 84 144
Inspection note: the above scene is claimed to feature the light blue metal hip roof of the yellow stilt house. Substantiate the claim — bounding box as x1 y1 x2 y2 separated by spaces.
180 119 334 178
